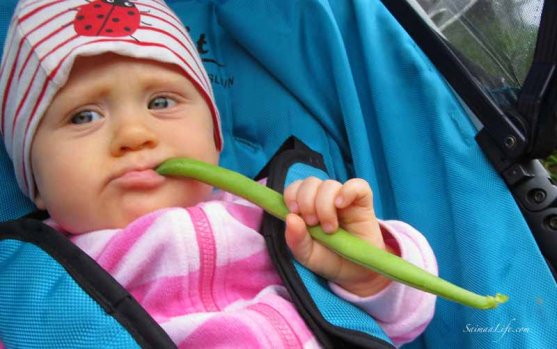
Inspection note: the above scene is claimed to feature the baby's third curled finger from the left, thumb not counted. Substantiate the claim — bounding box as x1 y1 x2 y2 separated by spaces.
315 180 342 233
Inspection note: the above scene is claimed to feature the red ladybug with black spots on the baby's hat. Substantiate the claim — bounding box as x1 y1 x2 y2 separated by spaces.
73 0 141 37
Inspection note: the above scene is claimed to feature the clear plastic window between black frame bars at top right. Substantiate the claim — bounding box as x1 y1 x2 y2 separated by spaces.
408 0 543 109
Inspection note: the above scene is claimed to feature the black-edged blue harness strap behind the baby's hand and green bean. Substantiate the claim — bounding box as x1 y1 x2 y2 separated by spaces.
257 137 392 348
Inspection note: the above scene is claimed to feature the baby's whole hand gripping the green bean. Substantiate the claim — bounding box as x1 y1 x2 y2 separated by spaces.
284 177 389 297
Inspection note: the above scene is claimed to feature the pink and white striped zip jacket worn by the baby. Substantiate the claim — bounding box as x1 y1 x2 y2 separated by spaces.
42 194 437 348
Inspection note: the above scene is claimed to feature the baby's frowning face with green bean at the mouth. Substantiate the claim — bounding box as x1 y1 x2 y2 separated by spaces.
31 54 218 233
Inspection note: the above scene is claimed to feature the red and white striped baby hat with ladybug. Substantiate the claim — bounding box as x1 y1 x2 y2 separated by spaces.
0 0 222 198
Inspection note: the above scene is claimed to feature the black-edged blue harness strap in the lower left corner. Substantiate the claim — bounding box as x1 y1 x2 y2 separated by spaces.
0 220 173 349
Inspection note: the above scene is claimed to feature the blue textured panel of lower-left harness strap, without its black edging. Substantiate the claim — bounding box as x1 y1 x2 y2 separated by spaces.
0 240 139 349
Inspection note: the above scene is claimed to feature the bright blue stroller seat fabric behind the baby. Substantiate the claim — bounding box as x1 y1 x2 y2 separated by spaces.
0 0 557 349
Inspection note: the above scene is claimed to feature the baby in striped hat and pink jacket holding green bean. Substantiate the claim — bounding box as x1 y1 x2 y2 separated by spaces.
0 0 437 348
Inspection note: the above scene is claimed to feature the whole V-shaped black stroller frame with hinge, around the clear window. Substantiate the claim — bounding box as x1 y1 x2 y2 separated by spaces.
381 0 557 282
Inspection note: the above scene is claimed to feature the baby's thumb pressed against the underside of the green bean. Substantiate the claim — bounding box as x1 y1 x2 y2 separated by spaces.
285 213 313 266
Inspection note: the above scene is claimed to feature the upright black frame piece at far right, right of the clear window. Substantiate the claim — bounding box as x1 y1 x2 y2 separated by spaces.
518 0 557 159
